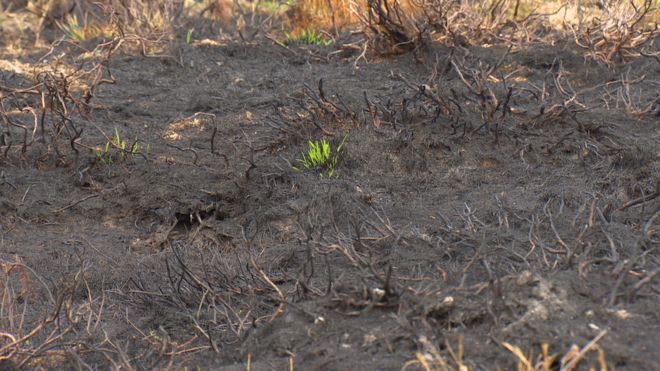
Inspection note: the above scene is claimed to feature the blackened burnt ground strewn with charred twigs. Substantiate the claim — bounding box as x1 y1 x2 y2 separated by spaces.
0 30 660 370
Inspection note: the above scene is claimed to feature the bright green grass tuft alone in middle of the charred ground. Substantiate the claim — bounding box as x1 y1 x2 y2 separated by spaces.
293 135 348 178
